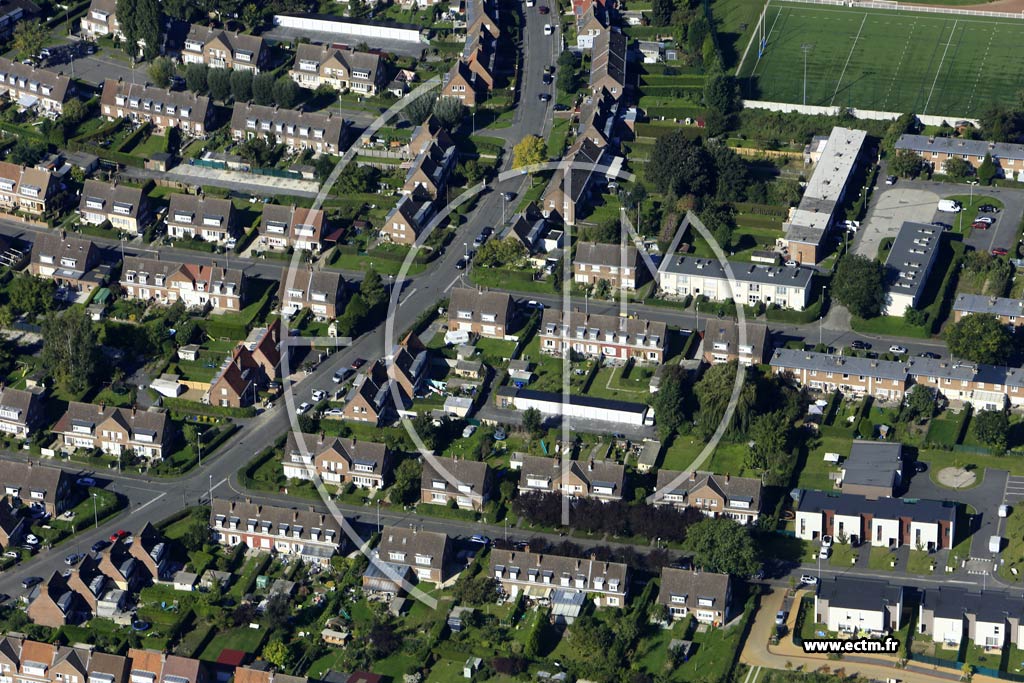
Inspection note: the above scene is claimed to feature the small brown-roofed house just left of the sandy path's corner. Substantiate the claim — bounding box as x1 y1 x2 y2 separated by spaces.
657 567 733 627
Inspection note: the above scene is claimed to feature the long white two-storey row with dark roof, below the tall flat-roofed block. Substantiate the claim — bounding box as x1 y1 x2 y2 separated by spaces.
658 256 814 310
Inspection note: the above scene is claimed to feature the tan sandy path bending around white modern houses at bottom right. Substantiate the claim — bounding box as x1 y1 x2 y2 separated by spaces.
739 589 999 683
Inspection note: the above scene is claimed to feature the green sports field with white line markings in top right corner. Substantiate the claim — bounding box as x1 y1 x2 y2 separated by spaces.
739 2 1024 118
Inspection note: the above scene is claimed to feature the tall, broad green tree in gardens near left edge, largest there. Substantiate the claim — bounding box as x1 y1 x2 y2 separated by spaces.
42 309 99 394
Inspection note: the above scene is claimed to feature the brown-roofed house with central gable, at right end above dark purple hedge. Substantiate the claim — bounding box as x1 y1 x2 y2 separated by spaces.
654 469 763 524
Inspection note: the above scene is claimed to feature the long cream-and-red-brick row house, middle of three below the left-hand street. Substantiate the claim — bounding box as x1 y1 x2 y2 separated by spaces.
121 256 247 313
